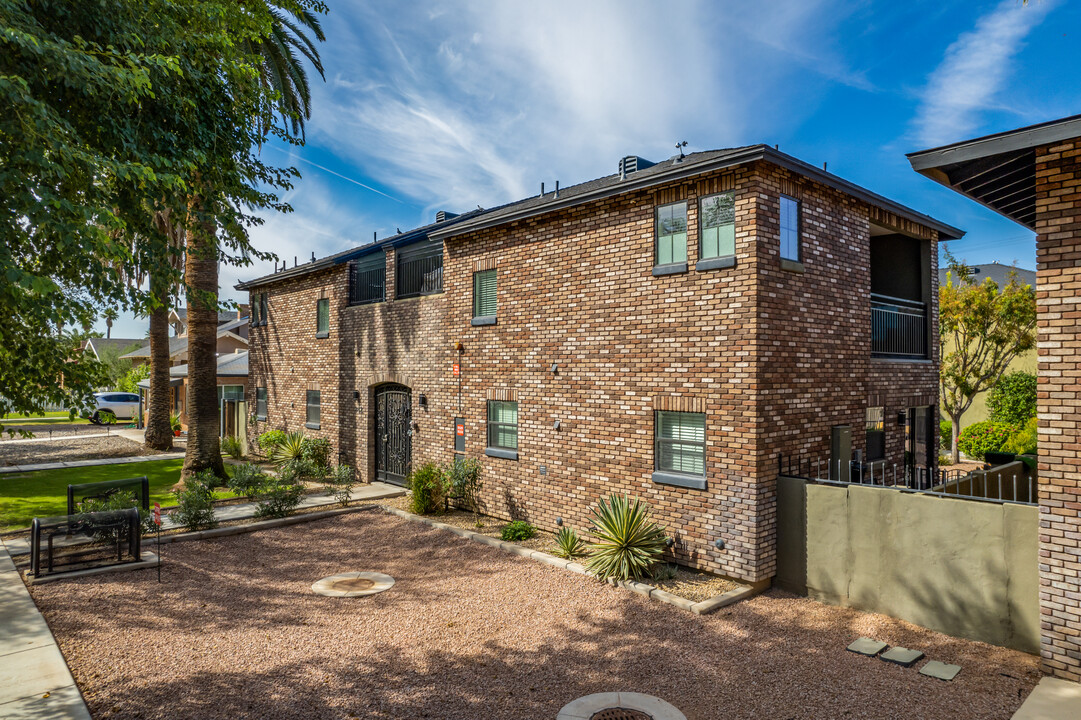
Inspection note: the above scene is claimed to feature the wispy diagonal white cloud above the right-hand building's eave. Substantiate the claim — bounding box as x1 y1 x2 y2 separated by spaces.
915 0 1055 146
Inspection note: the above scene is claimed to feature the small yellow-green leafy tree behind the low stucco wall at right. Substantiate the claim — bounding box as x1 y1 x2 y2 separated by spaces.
938 251 1036 463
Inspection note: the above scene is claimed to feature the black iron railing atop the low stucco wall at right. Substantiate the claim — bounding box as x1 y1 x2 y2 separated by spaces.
777 454 1037 505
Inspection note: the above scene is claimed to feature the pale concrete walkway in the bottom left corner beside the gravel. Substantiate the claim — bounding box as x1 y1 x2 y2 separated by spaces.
0 540 90 720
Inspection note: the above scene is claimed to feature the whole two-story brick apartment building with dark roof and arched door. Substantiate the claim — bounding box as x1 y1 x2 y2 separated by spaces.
239 145 961 581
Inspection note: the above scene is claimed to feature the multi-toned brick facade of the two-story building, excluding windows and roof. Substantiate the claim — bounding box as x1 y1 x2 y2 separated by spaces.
243 156 937 581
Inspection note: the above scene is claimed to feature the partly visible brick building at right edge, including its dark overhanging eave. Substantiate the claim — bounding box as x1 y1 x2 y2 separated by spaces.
909 116 1081 681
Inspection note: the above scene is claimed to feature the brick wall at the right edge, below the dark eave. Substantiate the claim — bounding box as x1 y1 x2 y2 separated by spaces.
1036 139 1081 681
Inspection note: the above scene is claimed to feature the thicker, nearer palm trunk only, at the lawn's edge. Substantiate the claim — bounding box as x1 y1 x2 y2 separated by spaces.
182 226 226 479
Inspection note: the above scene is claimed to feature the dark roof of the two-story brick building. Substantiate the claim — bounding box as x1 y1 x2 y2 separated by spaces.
236 145 964 290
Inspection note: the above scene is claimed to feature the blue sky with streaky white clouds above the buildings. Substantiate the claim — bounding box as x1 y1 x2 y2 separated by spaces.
99 0 1081 337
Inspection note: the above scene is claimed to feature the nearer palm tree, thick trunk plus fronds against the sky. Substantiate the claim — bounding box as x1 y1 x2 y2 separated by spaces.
183 2 325 478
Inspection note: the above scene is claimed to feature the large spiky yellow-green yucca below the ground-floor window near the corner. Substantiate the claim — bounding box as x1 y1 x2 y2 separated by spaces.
586 494 665 581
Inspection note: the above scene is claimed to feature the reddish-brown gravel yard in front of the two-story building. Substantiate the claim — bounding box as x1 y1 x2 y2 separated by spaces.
31 510 1038 720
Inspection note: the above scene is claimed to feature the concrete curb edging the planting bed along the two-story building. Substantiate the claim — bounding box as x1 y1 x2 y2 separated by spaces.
377 505 770 615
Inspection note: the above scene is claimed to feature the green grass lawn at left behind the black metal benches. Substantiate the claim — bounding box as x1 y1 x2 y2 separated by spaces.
0 457 232 532
